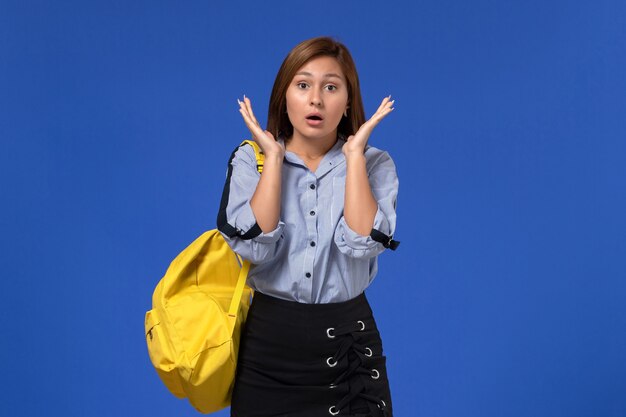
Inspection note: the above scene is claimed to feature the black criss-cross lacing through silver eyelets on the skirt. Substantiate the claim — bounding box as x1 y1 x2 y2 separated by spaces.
326 320 391 417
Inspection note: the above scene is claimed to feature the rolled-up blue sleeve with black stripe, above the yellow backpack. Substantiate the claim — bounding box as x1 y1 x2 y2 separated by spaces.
217 145 285 264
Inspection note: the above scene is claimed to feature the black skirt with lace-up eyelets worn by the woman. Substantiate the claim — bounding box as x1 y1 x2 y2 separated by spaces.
231 292 392 417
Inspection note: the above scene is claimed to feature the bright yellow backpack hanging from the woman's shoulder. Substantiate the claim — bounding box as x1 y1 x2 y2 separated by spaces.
145 141 263 413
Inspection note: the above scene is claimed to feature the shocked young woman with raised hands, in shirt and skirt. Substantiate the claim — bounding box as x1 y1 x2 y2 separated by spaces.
218 37 398 417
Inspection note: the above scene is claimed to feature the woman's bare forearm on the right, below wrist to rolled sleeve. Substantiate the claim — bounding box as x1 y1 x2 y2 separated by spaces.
343 152 378 236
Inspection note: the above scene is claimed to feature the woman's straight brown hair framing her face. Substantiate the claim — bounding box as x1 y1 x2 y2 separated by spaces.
267 36 365 139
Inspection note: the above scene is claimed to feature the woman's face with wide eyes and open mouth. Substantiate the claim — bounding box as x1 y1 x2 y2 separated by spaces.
286 56 348 139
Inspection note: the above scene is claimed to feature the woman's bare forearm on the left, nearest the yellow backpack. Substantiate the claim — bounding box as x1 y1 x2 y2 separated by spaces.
250 154 283 233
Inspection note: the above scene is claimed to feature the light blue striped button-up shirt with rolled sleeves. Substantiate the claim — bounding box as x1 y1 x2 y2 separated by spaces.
220 138 398 304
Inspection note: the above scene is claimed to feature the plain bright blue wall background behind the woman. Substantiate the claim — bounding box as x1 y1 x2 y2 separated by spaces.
0 0 626 417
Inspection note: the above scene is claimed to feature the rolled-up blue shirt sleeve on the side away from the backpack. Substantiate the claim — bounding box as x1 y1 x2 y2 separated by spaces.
334 151 398 258
